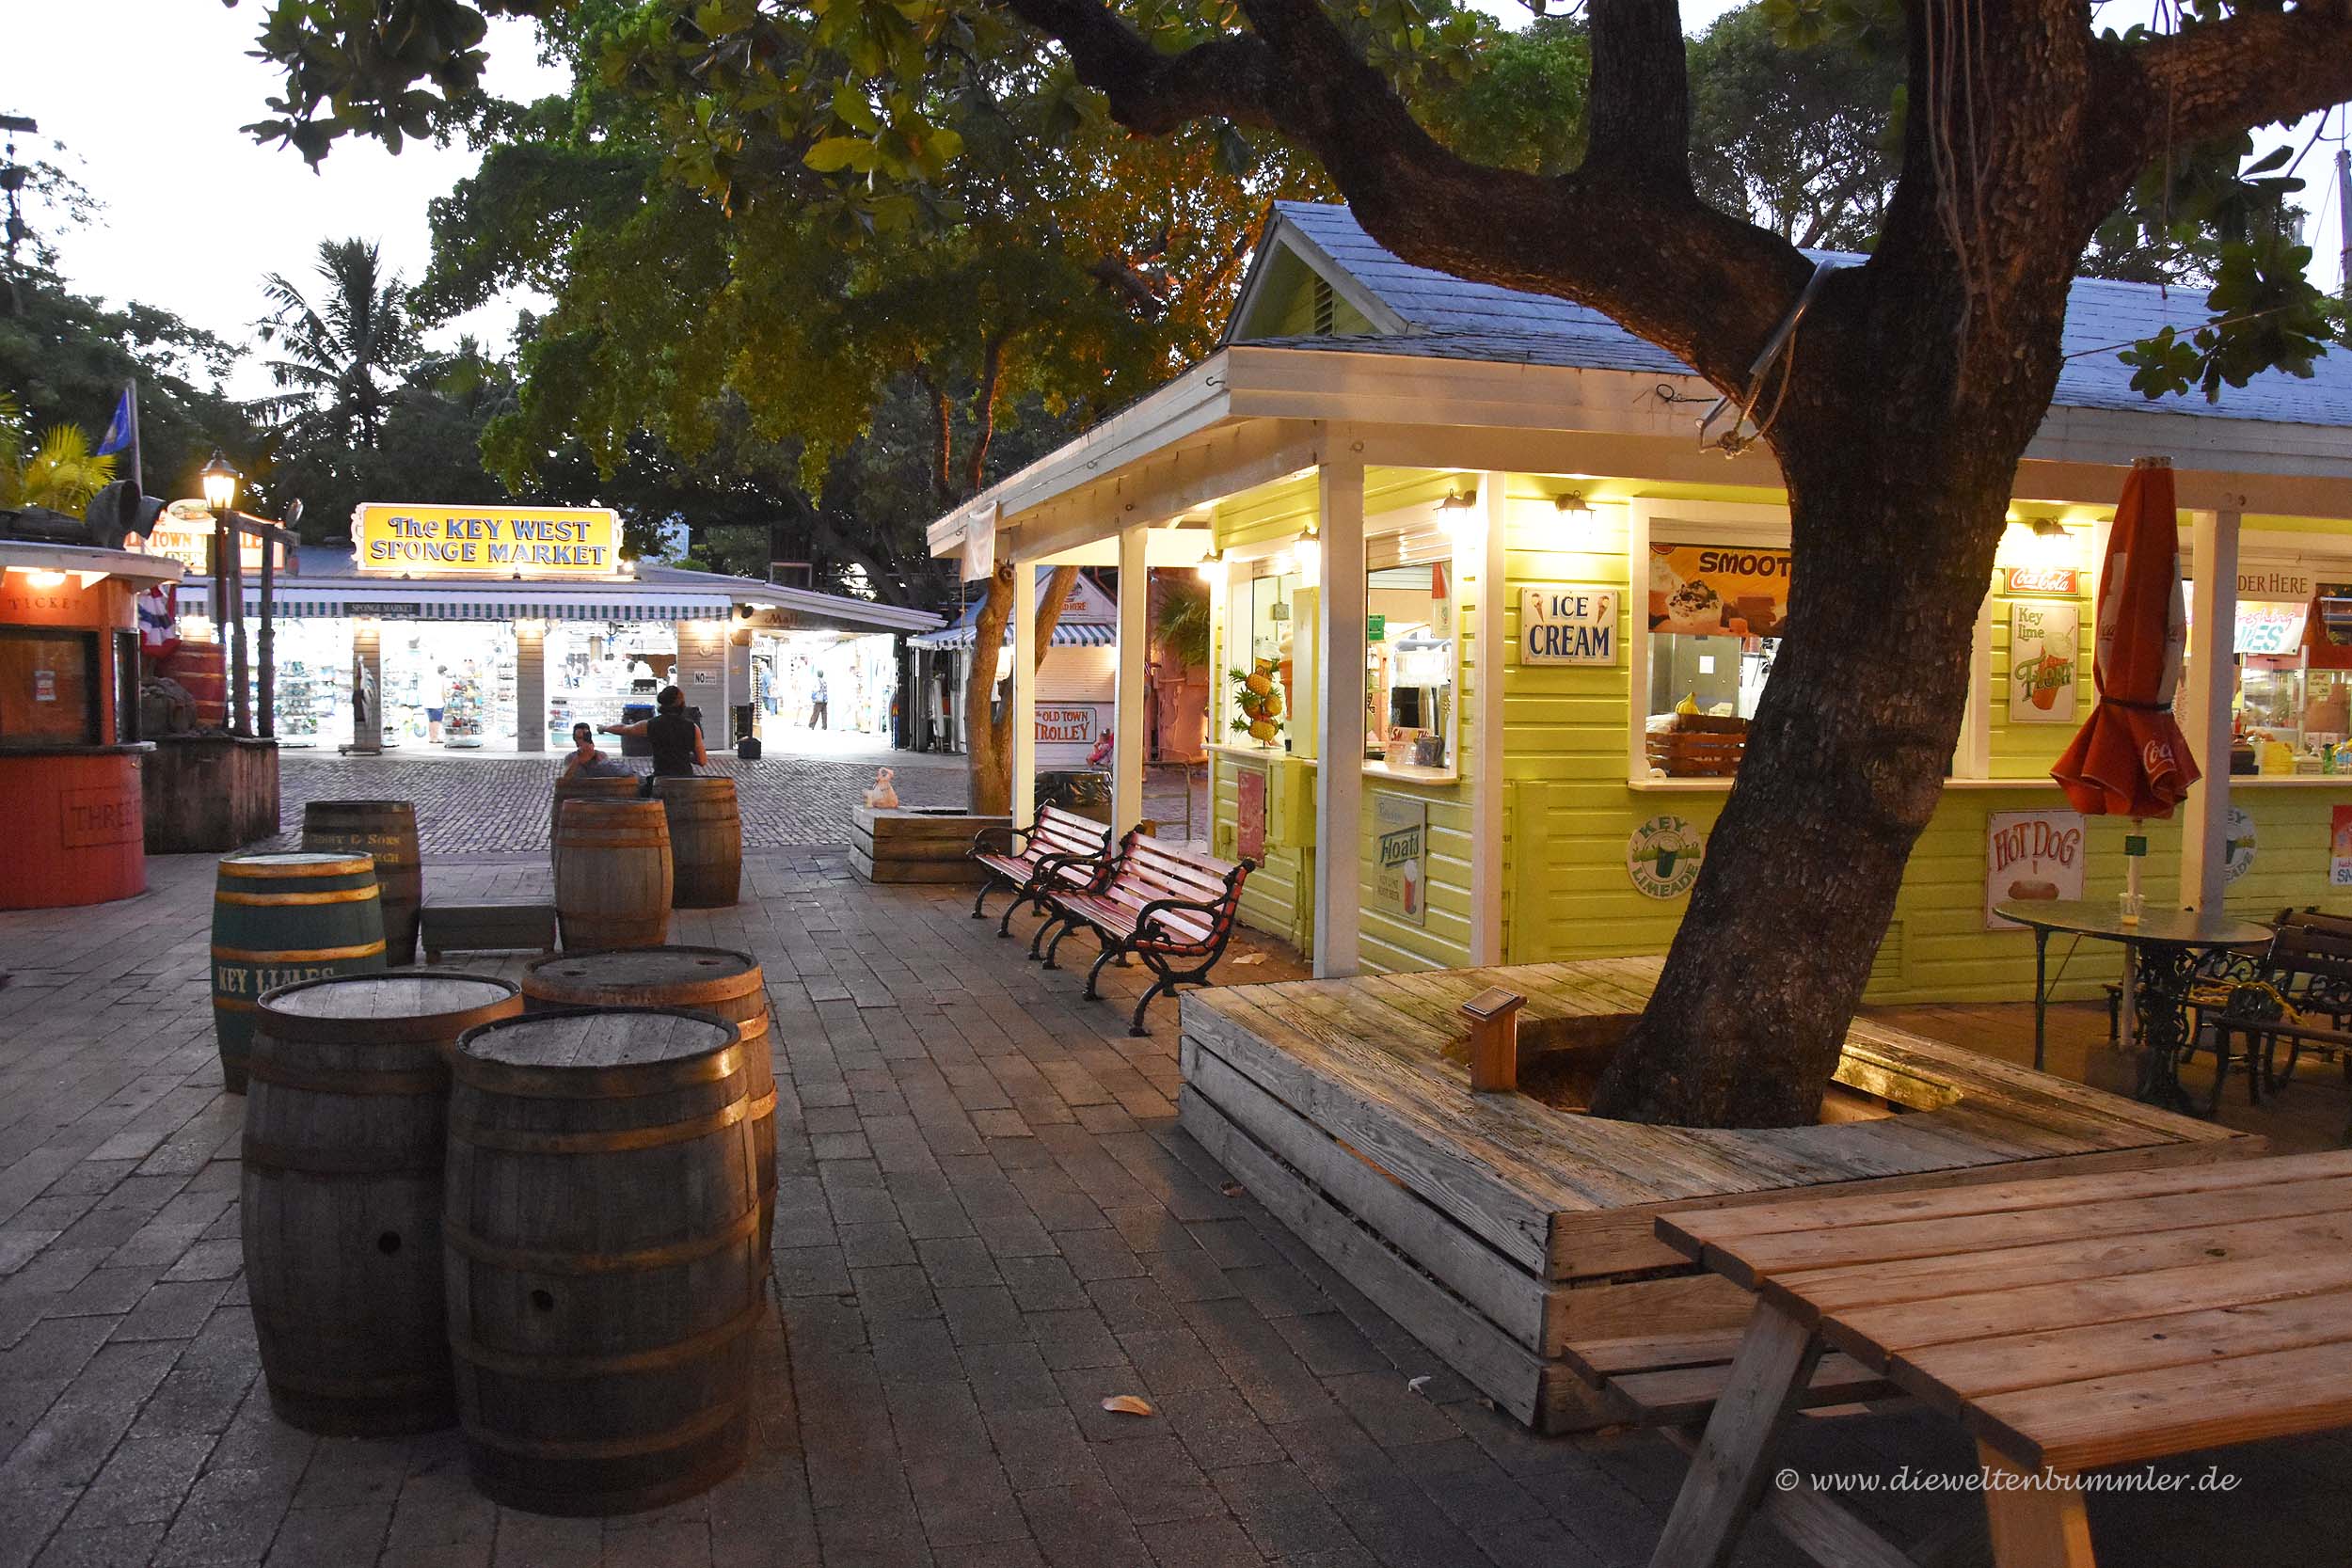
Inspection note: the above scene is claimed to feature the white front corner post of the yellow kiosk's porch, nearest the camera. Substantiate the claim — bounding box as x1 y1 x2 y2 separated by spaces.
1315 456 1364 978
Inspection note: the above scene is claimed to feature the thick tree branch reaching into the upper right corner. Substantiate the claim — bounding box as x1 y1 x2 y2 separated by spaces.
2107 0 2352 148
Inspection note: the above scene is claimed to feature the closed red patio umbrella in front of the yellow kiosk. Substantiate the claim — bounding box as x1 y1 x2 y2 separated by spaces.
2051 458 2197 822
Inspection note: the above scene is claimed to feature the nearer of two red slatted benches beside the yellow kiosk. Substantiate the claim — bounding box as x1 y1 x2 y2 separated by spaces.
1030 830 1256 1035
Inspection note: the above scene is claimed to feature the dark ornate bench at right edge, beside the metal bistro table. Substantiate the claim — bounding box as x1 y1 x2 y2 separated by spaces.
2190 910 2352 1123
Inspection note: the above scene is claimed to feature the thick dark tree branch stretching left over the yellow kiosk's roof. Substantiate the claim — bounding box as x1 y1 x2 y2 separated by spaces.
983 0 1811 388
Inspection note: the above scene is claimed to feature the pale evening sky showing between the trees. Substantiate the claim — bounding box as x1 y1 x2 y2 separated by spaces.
0 0 2341 423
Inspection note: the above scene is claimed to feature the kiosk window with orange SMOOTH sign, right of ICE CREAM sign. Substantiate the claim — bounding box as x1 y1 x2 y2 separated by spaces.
1645 541 1790 778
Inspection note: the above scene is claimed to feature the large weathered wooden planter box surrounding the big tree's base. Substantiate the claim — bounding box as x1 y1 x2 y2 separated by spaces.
1179 959 2263 1432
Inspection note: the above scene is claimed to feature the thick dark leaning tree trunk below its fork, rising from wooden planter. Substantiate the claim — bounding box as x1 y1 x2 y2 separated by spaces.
1593 441 2009 1126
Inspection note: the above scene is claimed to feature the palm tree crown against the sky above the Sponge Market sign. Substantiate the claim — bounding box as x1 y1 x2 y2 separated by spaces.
254 240 417 447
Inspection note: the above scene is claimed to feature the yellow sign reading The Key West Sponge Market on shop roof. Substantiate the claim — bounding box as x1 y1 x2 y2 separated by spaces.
351 500 621 578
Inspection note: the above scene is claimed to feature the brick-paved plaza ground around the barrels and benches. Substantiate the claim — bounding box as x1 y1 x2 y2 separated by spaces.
0 846 2352 1568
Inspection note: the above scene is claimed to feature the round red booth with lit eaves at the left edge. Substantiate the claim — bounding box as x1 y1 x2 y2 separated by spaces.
0 541 182 910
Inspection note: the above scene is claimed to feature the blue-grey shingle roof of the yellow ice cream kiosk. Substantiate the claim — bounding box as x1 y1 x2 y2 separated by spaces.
1289 202 2352 425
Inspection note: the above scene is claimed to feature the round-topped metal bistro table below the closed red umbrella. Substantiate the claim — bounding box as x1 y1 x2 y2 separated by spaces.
1993 898 2270 1112
